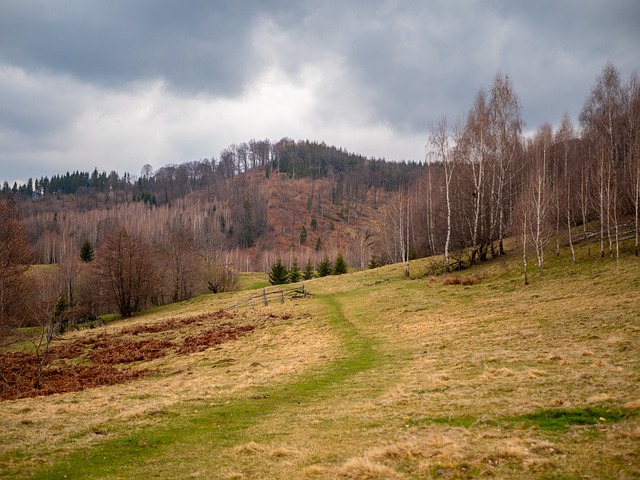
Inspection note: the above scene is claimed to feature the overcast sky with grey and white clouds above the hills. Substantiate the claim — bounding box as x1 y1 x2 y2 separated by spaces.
0 0 640 183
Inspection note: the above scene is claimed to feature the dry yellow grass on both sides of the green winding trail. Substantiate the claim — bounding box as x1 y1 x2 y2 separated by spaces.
0 246 640 479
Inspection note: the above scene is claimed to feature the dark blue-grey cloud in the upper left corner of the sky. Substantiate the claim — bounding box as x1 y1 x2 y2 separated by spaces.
0 0 272 95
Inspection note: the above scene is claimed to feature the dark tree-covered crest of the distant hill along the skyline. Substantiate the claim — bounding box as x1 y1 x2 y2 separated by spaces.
2 138 423 204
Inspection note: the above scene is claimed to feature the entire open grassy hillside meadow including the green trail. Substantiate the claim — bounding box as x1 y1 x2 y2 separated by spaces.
0 246 640 479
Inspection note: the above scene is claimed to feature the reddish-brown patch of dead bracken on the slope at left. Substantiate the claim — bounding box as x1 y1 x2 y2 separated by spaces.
0 311 255 400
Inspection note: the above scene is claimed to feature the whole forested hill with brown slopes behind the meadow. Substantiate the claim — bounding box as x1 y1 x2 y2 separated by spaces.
2 139 425 280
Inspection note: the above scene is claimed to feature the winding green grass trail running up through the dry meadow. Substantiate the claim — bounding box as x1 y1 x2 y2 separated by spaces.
33 295 381 480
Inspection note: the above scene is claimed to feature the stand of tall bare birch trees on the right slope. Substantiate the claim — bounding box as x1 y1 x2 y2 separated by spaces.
377 64 640 282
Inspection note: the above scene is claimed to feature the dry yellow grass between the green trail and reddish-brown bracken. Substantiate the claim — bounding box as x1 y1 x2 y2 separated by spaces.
0 304 340 474
